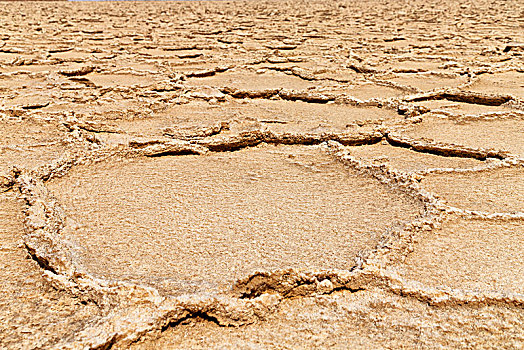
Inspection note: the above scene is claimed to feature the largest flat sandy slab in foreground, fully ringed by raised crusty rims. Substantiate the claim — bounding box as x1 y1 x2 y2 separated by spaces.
49 145 422 294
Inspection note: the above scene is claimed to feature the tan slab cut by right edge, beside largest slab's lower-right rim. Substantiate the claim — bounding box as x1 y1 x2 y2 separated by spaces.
395 218 524 294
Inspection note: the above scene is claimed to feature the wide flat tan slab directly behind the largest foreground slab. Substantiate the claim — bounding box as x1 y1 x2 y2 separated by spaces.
113 100 398 139
